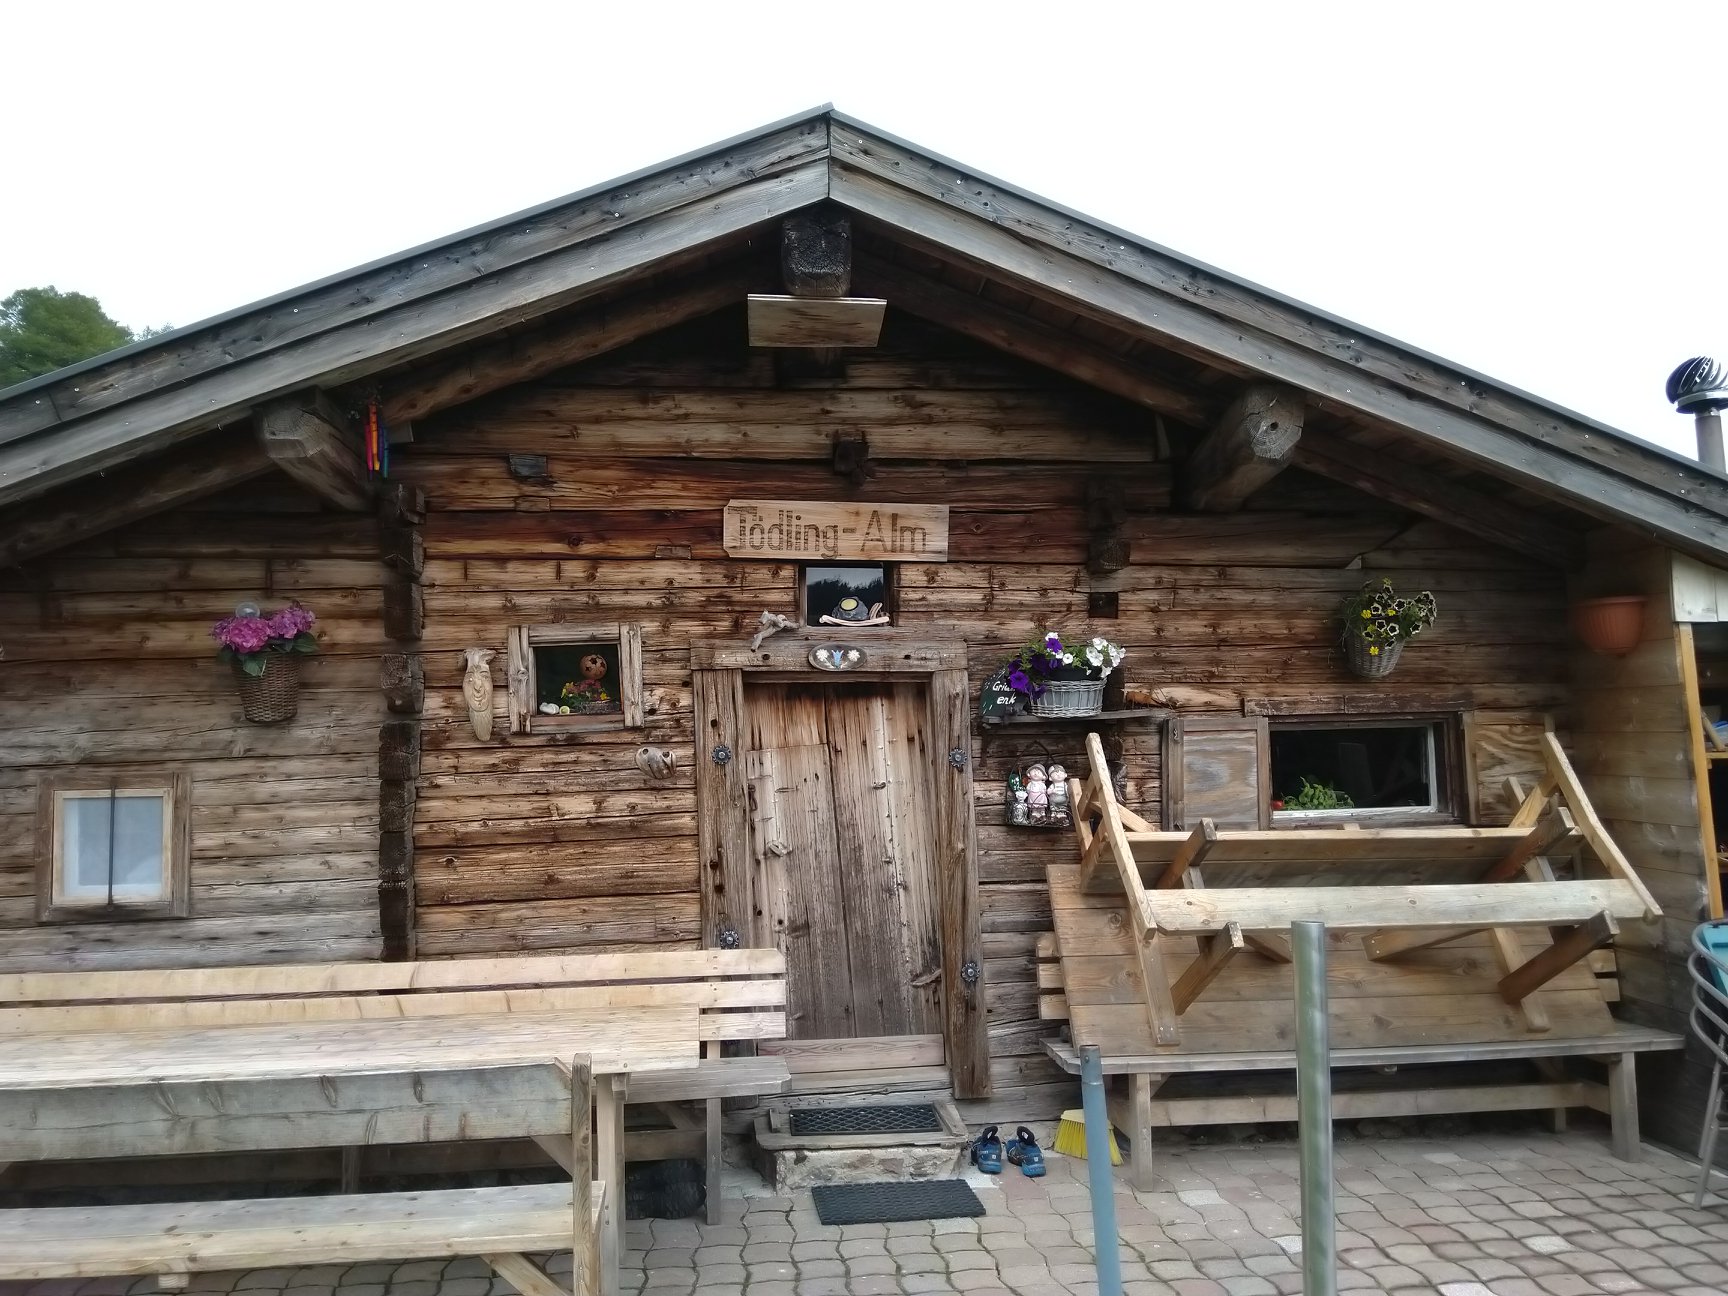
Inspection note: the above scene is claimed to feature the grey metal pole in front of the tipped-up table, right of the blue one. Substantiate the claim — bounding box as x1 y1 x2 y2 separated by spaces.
1299 923 1337 1296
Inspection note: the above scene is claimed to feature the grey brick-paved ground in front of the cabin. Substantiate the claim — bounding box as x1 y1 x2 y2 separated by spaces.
13 1130 1728 1296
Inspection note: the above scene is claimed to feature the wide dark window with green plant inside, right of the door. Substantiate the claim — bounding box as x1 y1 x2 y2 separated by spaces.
1272 721 1453 823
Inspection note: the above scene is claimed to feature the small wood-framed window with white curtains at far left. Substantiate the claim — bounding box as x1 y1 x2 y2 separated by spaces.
36 769 192 923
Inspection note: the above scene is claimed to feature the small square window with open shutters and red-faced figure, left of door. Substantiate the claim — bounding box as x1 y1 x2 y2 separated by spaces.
508 626 643 734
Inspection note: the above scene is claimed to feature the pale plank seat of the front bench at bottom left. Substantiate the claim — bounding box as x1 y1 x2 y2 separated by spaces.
0 1180 607 1279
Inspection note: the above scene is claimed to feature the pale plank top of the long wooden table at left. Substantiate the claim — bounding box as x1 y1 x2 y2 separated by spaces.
0 1004 700 1090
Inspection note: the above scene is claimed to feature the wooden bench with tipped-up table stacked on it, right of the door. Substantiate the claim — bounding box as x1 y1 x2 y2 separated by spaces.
1039 734 1683 1178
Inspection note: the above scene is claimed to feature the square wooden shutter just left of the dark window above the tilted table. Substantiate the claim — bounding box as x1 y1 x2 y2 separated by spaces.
1163 715 1272 829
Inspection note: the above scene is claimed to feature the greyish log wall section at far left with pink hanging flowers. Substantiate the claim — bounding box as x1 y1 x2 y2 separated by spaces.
0 482 384 971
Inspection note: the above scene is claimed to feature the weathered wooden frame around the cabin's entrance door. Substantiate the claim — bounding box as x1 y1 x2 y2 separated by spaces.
689 629 990 1097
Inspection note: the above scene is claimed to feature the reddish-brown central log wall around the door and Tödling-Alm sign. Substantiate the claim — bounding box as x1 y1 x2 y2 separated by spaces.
397 313 1566 1090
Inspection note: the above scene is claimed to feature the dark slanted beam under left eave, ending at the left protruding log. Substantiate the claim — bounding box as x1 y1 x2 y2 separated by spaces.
0 432 271 567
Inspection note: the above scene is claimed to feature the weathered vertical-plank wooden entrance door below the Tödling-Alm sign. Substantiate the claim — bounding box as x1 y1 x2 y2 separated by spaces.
745 683 942 1040
